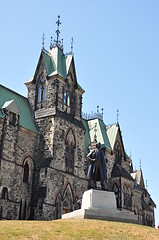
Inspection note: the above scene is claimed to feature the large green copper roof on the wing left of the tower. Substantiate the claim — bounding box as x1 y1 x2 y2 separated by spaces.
0 85 38 133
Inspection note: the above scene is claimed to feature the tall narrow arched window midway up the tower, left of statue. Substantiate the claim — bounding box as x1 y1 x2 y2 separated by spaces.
65 128 76 173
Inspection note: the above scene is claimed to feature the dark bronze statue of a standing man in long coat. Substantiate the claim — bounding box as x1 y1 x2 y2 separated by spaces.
87 142 107 190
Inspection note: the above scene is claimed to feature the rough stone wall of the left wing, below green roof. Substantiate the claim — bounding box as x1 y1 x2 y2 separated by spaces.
0 112 36 219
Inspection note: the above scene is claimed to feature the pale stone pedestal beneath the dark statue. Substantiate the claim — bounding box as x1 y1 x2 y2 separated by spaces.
62 189 138 223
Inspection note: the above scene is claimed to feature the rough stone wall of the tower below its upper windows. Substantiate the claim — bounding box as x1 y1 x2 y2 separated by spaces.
35 110 88 219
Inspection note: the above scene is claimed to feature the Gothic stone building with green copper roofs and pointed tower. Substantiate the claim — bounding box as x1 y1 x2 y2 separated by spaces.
0 17 156 226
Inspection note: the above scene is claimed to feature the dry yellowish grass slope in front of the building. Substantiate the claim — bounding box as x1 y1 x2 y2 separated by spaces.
0 219 159 240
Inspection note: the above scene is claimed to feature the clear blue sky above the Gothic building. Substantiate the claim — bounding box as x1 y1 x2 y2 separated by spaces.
0 0 159 225
